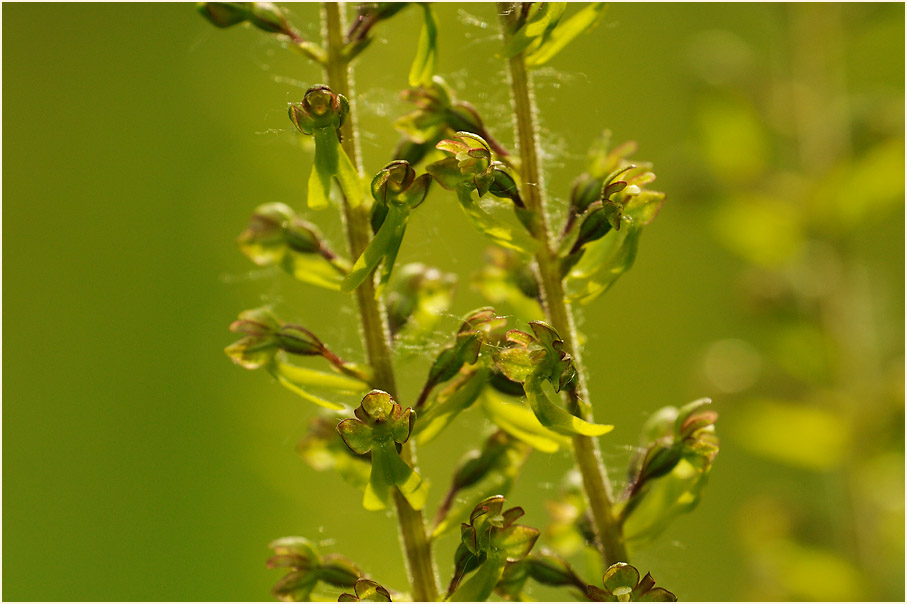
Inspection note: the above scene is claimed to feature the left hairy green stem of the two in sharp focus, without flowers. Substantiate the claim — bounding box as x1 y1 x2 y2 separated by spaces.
323 2 438 602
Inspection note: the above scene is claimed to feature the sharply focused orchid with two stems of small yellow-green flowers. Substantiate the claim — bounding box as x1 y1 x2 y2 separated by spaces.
198 2 718 602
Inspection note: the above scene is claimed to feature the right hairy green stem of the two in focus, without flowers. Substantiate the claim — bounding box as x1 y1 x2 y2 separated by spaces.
498 2 629 566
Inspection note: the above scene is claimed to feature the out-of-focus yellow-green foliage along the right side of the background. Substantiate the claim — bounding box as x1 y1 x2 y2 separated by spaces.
696 4 904 600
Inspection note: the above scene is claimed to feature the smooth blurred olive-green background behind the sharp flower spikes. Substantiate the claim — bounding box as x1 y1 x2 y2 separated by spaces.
3 3 904 600
